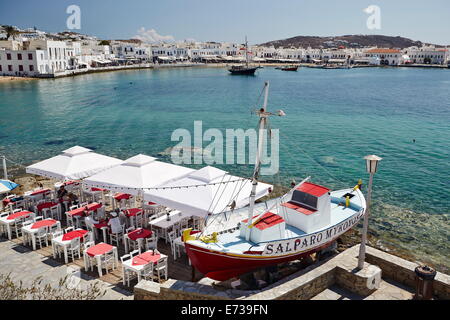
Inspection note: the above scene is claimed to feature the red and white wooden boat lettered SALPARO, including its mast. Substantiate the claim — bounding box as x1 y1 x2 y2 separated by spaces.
182 82 366 281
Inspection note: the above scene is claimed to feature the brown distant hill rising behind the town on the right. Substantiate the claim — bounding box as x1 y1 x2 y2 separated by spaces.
260 35 439 49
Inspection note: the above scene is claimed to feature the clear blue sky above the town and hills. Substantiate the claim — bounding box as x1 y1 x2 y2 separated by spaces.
0 0 450 45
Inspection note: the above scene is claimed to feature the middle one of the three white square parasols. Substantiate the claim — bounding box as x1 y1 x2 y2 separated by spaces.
83 154 194 195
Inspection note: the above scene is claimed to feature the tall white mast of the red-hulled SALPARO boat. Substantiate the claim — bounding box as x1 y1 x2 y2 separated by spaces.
245 81 269 241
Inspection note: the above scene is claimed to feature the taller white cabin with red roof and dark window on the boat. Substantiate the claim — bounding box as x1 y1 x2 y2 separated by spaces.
278 182 331 233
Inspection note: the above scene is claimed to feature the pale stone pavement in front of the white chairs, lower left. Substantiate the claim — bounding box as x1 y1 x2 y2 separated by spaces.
0 239 133 300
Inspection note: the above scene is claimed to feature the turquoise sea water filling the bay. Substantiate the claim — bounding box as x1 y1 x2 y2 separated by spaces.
0 68 450 266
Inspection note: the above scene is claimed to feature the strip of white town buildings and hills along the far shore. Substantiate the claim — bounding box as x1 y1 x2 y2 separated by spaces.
0 26 450 77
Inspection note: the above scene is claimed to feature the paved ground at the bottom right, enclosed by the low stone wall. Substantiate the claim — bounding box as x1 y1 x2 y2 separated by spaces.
311 279 414 300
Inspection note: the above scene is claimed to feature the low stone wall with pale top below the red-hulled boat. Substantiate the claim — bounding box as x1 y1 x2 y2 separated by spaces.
134 245 450 301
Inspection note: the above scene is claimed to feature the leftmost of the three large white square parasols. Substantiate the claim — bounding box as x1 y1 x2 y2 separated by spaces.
26 146 123 180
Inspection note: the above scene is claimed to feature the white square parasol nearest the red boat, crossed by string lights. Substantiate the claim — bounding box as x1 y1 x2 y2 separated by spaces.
144 166 272 217
